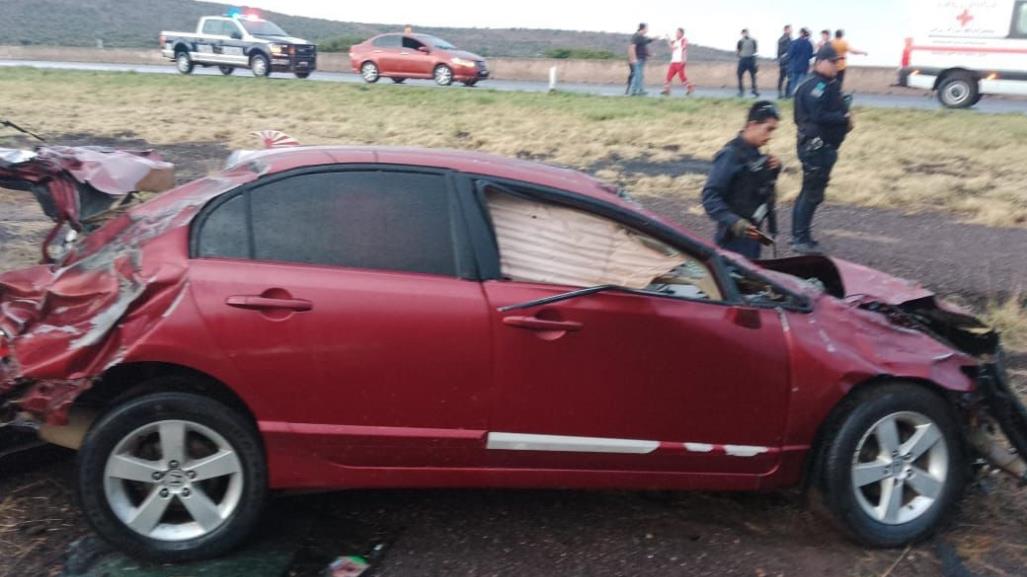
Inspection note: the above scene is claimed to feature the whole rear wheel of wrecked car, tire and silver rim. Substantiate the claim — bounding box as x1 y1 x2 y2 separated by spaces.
77 392 267 563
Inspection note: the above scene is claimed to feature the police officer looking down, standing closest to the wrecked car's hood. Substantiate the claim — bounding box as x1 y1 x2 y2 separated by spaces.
702 101 781 259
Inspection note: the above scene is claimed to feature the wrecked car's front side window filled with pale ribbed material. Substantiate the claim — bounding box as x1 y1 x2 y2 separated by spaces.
485 187 722 300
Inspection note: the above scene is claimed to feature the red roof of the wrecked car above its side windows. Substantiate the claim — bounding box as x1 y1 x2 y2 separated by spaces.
231 146 621 204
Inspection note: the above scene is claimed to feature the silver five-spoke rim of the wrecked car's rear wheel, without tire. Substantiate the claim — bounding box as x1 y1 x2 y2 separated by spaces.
104 420 243 541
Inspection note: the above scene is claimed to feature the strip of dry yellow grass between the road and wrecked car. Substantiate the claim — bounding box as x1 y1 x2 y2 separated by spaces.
0 69 1027 227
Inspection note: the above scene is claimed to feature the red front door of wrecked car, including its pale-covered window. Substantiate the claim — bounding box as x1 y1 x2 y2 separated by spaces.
472 181 789 474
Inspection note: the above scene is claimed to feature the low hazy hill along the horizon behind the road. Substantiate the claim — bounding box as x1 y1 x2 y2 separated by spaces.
0 0 734 61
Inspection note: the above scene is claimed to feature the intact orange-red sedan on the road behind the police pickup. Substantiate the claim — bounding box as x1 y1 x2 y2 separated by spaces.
349 34 489 86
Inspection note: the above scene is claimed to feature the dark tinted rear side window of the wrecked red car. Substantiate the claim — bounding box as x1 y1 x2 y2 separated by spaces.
195 171 458 276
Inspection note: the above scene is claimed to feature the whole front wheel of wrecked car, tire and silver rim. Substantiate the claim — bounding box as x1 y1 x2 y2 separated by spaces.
822 383 968 547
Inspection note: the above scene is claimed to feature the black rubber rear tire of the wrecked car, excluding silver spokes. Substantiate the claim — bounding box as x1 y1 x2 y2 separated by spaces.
76 383 267 563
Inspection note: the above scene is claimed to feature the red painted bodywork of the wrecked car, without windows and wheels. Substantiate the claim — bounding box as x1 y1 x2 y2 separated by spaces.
0 147 978 490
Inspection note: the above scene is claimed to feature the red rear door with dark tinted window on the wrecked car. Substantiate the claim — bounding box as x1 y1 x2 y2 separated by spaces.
190 169 491 466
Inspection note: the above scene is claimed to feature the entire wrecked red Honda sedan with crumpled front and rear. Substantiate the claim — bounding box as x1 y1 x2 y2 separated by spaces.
0 147 1027 561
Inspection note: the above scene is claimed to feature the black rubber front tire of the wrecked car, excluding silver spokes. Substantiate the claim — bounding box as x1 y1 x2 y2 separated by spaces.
820 383 969 547
